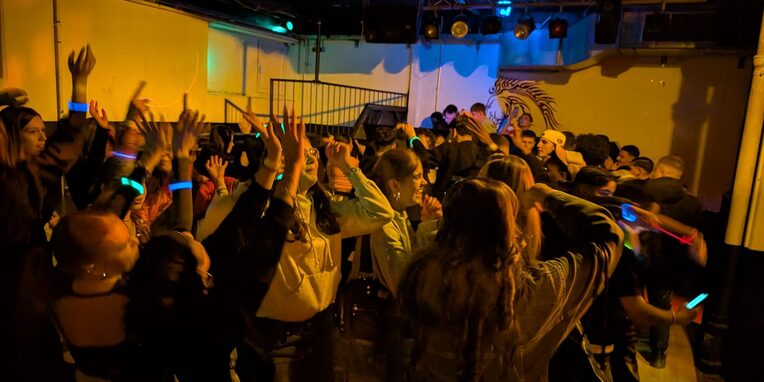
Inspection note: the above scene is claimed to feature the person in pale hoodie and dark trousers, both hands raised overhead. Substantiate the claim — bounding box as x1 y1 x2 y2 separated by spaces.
237 116 393 381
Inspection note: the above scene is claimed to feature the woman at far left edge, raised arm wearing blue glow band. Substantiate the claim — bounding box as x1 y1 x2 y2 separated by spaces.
0 46 96 381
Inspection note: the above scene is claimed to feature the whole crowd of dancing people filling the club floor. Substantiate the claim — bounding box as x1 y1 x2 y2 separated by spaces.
0 46 707 381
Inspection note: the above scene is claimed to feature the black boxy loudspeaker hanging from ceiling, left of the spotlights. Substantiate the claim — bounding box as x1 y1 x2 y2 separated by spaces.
363 6 417 44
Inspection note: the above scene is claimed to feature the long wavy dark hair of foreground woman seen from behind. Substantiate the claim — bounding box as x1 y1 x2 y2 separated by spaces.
399 178 523 381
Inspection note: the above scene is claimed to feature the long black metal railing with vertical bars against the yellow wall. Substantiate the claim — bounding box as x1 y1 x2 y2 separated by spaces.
269 78 408 135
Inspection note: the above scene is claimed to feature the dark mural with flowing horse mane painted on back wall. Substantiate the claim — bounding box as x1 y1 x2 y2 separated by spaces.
486 77 560 131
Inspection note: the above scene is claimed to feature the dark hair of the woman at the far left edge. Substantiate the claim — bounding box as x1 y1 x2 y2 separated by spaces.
0 106 40 168
